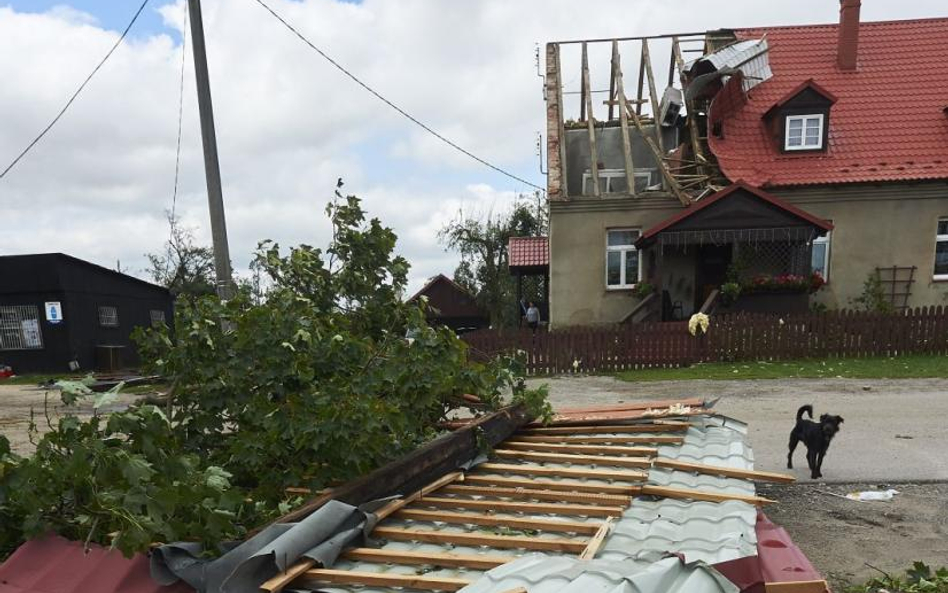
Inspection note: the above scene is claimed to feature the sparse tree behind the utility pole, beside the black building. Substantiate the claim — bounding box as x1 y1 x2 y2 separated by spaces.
145 212 216 297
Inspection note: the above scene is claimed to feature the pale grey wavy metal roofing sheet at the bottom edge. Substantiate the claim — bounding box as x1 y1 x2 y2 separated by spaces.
461 555 738 593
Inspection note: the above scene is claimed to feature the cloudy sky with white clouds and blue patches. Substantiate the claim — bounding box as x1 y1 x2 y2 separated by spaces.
0 0 948 290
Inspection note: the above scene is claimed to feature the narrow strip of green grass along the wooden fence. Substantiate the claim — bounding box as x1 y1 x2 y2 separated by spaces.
616 355 948 381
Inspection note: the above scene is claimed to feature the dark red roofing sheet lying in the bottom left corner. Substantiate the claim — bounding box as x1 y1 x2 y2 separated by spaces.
0 536 194 593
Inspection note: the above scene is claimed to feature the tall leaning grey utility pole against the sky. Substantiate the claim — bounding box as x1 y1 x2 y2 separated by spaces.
187 0 234 300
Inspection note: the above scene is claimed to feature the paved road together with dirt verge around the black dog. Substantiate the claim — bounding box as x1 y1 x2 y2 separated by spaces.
530 376 948 591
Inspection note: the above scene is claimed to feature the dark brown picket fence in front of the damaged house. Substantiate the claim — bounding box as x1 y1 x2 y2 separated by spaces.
463 306 948 374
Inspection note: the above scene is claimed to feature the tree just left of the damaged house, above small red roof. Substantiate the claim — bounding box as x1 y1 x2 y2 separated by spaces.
439 196 546 327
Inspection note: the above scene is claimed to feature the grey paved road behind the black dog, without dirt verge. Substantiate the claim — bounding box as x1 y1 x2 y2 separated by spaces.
531 377 948 483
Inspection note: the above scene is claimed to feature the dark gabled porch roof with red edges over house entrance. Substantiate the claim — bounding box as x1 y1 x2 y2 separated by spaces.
635 180 833 248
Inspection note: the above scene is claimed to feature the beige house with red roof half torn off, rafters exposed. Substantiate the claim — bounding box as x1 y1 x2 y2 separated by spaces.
546 0 948 327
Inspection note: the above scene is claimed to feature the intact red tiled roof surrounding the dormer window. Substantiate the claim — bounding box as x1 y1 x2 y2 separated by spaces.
709 18 948 187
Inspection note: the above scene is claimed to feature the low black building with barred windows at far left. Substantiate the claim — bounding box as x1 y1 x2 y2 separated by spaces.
0 253 173 374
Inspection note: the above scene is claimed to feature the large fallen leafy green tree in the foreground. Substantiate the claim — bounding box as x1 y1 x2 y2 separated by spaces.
0 187 549 554
